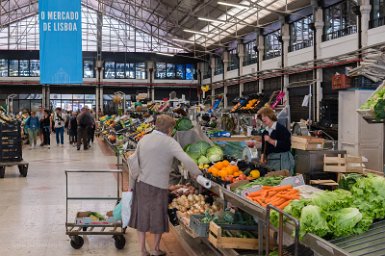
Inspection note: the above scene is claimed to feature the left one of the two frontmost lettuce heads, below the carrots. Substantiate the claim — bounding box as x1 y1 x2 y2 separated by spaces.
300 205 330 238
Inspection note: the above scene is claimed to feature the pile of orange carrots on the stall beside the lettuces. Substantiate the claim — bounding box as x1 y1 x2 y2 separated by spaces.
246 185 300 209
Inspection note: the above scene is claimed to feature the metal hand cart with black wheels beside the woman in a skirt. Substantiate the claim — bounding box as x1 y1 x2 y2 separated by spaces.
65 170 126 249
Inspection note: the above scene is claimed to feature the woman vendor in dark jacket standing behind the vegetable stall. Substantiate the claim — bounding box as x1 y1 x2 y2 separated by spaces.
258 107 294 174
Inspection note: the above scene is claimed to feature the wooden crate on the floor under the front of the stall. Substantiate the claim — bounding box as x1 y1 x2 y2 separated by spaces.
209 221 258 250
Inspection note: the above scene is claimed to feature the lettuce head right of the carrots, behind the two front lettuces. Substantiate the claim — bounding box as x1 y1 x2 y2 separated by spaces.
312 189 353 211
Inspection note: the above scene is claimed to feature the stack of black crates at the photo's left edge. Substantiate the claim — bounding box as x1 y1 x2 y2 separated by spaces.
0 122 23 162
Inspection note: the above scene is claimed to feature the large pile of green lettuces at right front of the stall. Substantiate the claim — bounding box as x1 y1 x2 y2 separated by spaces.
271 174 385 238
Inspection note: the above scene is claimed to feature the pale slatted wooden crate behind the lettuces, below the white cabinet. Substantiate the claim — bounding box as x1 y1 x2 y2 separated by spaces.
324 154 365 173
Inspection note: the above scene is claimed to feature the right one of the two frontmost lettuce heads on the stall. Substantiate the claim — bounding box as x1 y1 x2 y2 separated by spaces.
329 208 362 237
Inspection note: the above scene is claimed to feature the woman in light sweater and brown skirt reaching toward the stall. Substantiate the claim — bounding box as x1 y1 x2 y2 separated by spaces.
129 115 201 256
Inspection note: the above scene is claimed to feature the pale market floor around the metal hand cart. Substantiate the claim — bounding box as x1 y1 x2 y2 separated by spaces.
0 138 139 256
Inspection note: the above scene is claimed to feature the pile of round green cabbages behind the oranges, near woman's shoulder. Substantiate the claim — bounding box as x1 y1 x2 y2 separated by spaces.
184 141 223 164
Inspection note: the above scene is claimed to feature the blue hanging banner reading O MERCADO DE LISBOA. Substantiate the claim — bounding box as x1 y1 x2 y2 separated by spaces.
39 0 83 84
